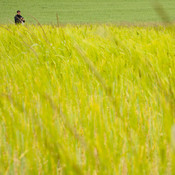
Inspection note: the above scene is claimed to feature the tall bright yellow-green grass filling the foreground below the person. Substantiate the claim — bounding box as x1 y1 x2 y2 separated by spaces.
0 25 175 175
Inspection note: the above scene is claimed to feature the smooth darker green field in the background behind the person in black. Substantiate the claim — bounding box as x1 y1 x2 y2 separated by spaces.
0 0 175 24
